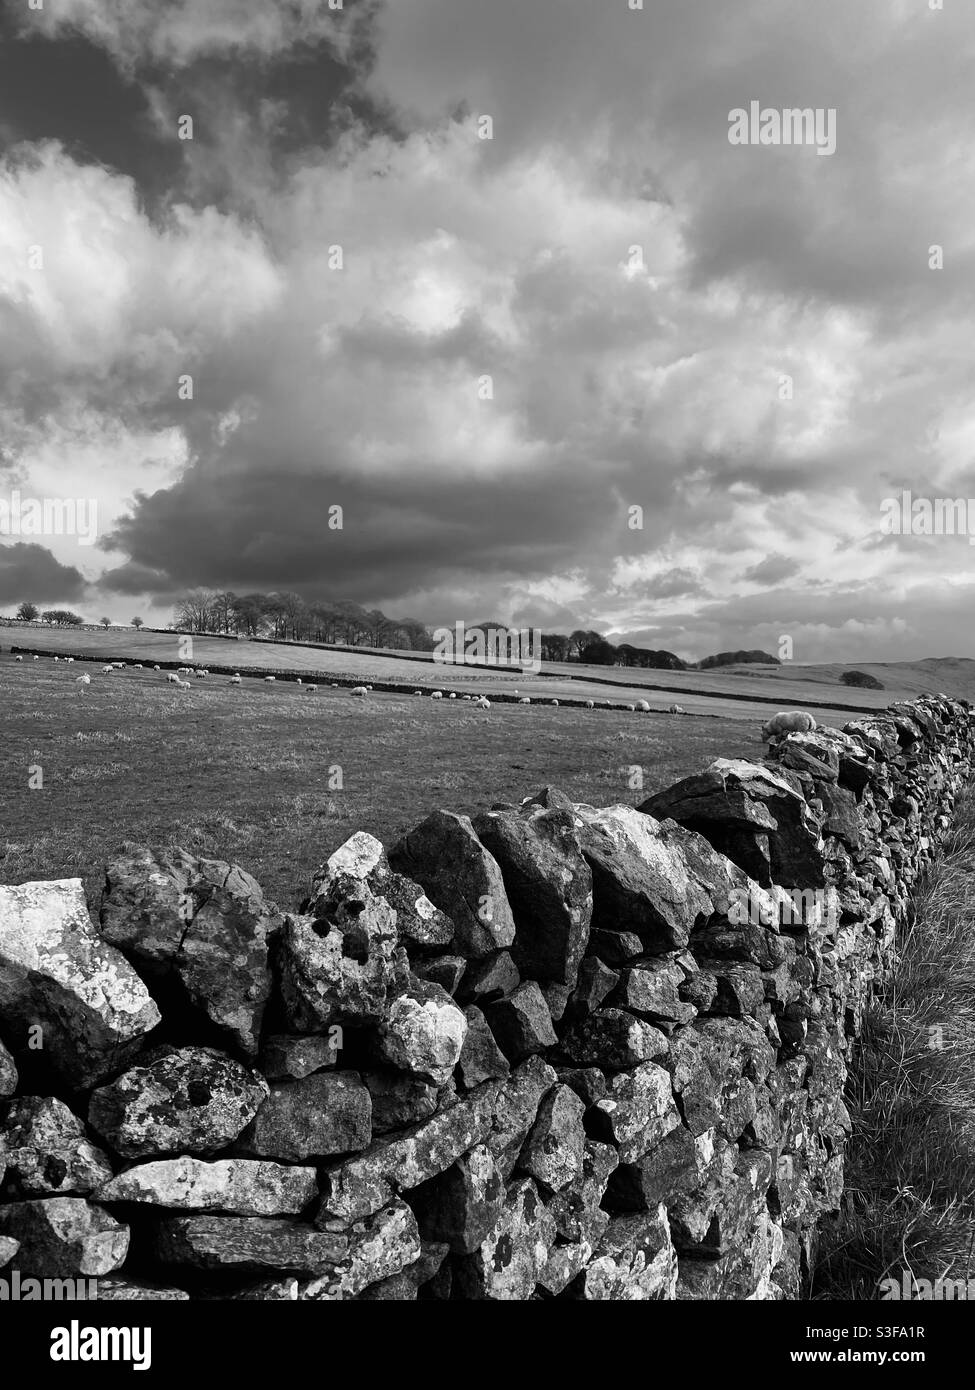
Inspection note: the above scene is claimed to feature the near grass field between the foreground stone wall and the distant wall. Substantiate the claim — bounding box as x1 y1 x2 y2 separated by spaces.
0 644 764 906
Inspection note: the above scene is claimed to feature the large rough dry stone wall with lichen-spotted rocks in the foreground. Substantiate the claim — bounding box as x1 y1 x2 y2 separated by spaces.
0 698 975 1300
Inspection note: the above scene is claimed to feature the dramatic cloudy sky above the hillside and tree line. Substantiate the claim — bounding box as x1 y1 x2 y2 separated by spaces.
0 0 975 662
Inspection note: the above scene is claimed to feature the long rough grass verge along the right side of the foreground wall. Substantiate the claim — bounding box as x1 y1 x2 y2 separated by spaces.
811 794 975 1300
